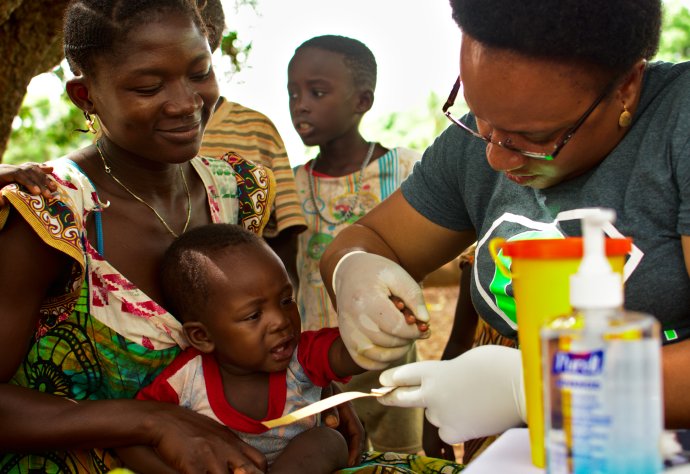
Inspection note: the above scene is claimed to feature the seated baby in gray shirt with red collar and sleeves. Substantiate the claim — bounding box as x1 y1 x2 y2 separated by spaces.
127 224 368 473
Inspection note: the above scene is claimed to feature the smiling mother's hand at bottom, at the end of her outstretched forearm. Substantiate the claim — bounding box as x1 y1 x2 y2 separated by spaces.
141 402 268 474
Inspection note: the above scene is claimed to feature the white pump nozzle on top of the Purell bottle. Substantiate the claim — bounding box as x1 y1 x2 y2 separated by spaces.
570 208 623 309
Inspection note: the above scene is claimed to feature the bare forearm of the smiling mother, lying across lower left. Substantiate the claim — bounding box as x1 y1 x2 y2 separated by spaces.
0 384 153 452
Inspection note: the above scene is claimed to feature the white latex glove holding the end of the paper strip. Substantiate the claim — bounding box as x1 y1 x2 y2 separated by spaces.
378 346 527 444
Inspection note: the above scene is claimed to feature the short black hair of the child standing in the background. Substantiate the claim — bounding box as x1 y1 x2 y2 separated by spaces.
295 35 377 91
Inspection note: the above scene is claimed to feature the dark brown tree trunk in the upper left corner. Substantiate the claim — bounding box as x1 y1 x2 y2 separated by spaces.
0 0 68 162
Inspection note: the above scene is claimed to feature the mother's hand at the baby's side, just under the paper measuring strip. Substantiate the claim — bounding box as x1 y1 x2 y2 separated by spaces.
321 383 366 467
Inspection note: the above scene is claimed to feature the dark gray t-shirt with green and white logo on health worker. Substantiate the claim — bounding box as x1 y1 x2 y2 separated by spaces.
401 63 690 342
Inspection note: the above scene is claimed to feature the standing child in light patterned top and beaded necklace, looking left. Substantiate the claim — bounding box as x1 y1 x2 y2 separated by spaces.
288 35 422 453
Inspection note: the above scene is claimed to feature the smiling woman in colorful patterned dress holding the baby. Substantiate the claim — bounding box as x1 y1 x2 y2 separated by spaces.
0 0 275 473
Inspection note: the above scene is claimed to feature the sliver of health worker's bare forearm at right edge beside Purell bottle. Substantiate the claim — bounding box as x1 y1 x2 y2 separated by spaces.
661 339 690 429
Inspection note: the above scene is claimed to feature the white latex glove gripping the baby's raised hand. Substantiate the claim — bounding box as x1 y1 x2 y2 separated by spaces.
333 251 430 370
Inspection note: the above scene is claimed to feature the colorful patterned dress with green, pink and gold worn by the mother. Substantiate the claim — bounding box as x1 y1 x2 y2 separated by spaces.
0 155 275 473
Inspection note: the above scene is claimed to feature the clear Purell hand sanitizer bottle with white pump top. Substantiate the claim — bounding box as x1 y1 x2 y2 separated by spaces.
541 208 663 474
